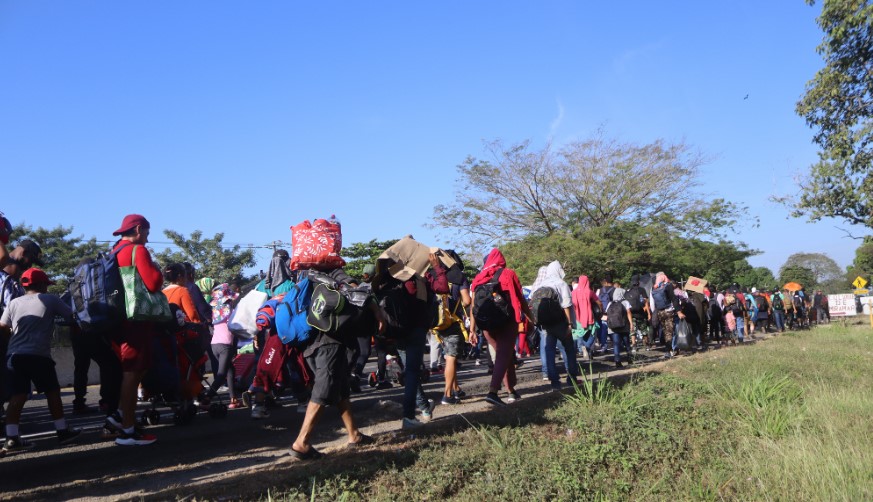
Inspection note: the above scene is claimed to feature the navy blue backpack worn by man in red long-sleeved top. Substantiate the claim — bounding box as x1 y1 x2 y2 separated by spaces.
68 244 131 331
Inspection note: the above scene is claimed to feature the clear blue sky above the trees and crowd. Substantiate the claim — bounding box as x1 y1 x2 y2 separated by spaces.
0 0 848 272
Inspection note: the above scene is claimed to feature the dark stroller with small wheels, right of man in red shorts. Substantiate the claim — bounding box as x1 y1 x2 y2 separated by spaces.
140 305 227 425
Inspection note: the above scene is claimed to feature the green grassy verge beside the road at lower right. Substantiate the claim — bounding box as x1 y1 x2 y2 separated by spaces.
258 326 873 501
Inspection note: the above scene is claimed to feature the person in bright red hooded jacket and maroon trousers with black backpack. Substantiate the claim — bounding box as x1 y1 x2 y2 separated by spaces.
470 248 533 405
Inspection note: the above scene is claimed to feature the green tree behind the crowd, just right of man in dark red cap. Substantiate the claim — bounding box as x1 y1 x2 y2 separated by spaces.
156 230 255 283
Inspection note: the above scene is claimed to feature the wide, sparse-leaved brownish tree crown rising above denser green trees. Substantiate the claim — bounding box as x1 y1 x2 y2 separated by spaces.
431 132 745 248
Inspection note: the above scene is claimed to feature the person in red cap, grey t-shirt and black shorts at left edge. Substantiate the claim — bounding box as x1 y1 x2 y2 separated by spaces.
0 268 81 453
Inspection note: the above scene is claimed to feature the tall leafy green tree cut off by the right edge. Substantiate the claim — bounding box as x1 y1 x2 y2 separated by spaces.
782 0 873 228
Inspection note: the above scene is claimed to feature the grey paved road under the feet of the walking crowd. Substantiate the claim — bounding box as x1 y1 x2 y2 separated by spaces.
0 342 700 500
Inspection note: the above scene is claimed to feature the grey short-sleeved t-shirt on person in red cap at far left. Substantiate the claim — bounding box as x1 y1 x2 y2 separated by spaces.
0 293 73 358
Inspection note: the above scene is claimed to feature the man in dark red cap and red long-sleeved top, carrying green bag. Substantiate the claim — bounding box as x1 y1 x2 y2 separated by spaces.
105 214 164 446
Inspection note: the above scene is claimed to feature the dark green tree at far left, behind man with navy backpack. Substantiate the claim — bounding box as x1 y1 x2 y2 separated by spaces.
10 223 102 294
